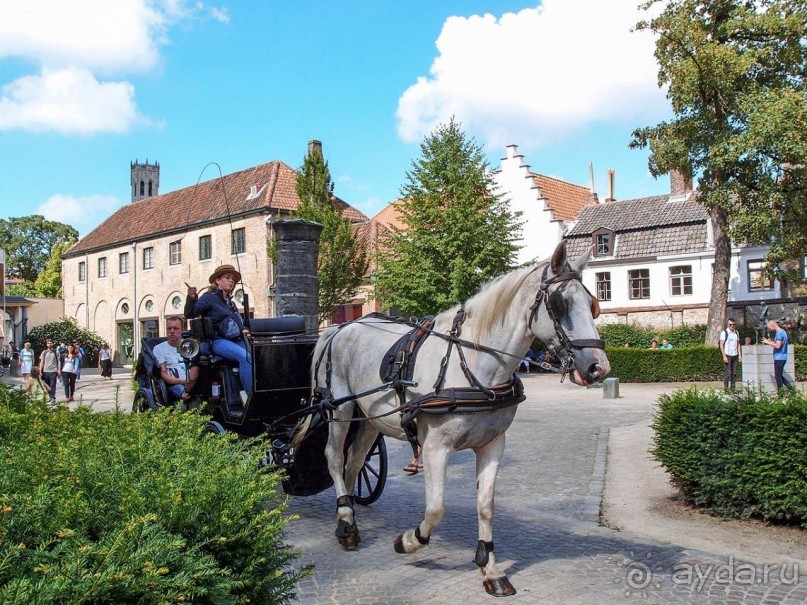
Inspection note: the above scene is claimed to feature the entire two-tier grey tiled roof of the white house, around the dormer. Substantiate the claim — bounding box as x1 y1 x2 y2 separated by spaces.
565 195 709 259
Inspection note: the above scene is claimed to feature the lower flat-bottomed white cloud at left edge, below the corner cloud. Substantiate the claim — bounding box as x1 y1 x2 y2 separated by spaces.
0 68 142 135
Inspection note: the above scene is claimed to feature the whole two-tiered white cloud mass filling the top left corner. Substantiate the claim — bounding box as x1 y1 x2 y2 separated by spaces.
0 0 229 134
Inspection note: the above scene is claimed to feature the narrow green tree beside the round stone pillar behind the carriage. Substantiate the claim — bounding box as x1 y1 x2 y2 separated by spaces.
296 147 369 321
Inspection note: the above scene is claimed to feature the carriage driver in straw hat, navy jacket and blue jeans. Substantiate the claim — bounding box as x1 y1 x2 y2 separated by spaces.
185 265 252 404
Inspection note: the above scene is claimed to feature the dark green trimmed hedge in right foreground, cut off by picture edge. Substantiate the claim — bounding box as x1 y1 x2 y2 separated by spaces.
652 388 807 529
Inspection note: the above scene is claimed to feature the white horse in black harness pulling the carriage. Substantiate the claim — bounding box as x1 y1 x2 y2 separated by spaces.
296 243 610 596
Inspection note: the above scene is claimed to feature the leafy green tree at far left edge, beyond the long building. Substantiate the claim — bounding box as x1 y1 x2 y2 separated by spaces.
0 214 78 283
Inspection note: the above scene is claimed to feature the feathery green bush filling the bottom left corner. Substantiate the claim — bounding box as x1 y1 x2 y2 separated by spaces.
0 385 308 605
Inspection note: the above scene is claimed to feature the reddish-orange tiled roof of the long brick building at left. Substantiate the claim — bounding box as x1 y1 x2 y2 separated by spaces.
65 160 367 257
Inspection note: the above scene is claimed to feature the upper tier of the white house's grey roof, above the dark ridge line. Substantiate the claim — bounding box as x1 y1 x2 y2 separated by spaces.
568 195 709 237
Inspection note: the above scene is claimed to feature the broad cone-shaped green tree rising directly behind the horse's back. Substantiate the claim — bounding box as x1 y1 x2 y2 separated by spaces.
376 118 521 315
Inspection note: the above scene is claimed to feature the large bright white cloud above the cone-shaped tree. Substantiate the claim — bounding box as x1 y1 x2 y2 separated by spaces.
397 0 666 148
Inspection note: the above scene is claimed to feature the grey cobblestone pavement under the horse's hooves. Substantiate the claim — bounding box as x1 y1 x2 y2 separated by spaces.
288 375 807 605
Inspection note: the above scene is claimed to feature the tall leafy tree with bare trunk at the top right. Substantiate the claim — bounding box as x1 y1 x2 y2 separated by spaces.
631 0 807 344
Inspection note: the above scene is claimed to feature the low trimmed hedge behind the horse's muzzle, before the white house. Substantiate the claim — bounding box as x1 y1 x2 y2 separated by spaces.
605 345 723 382
